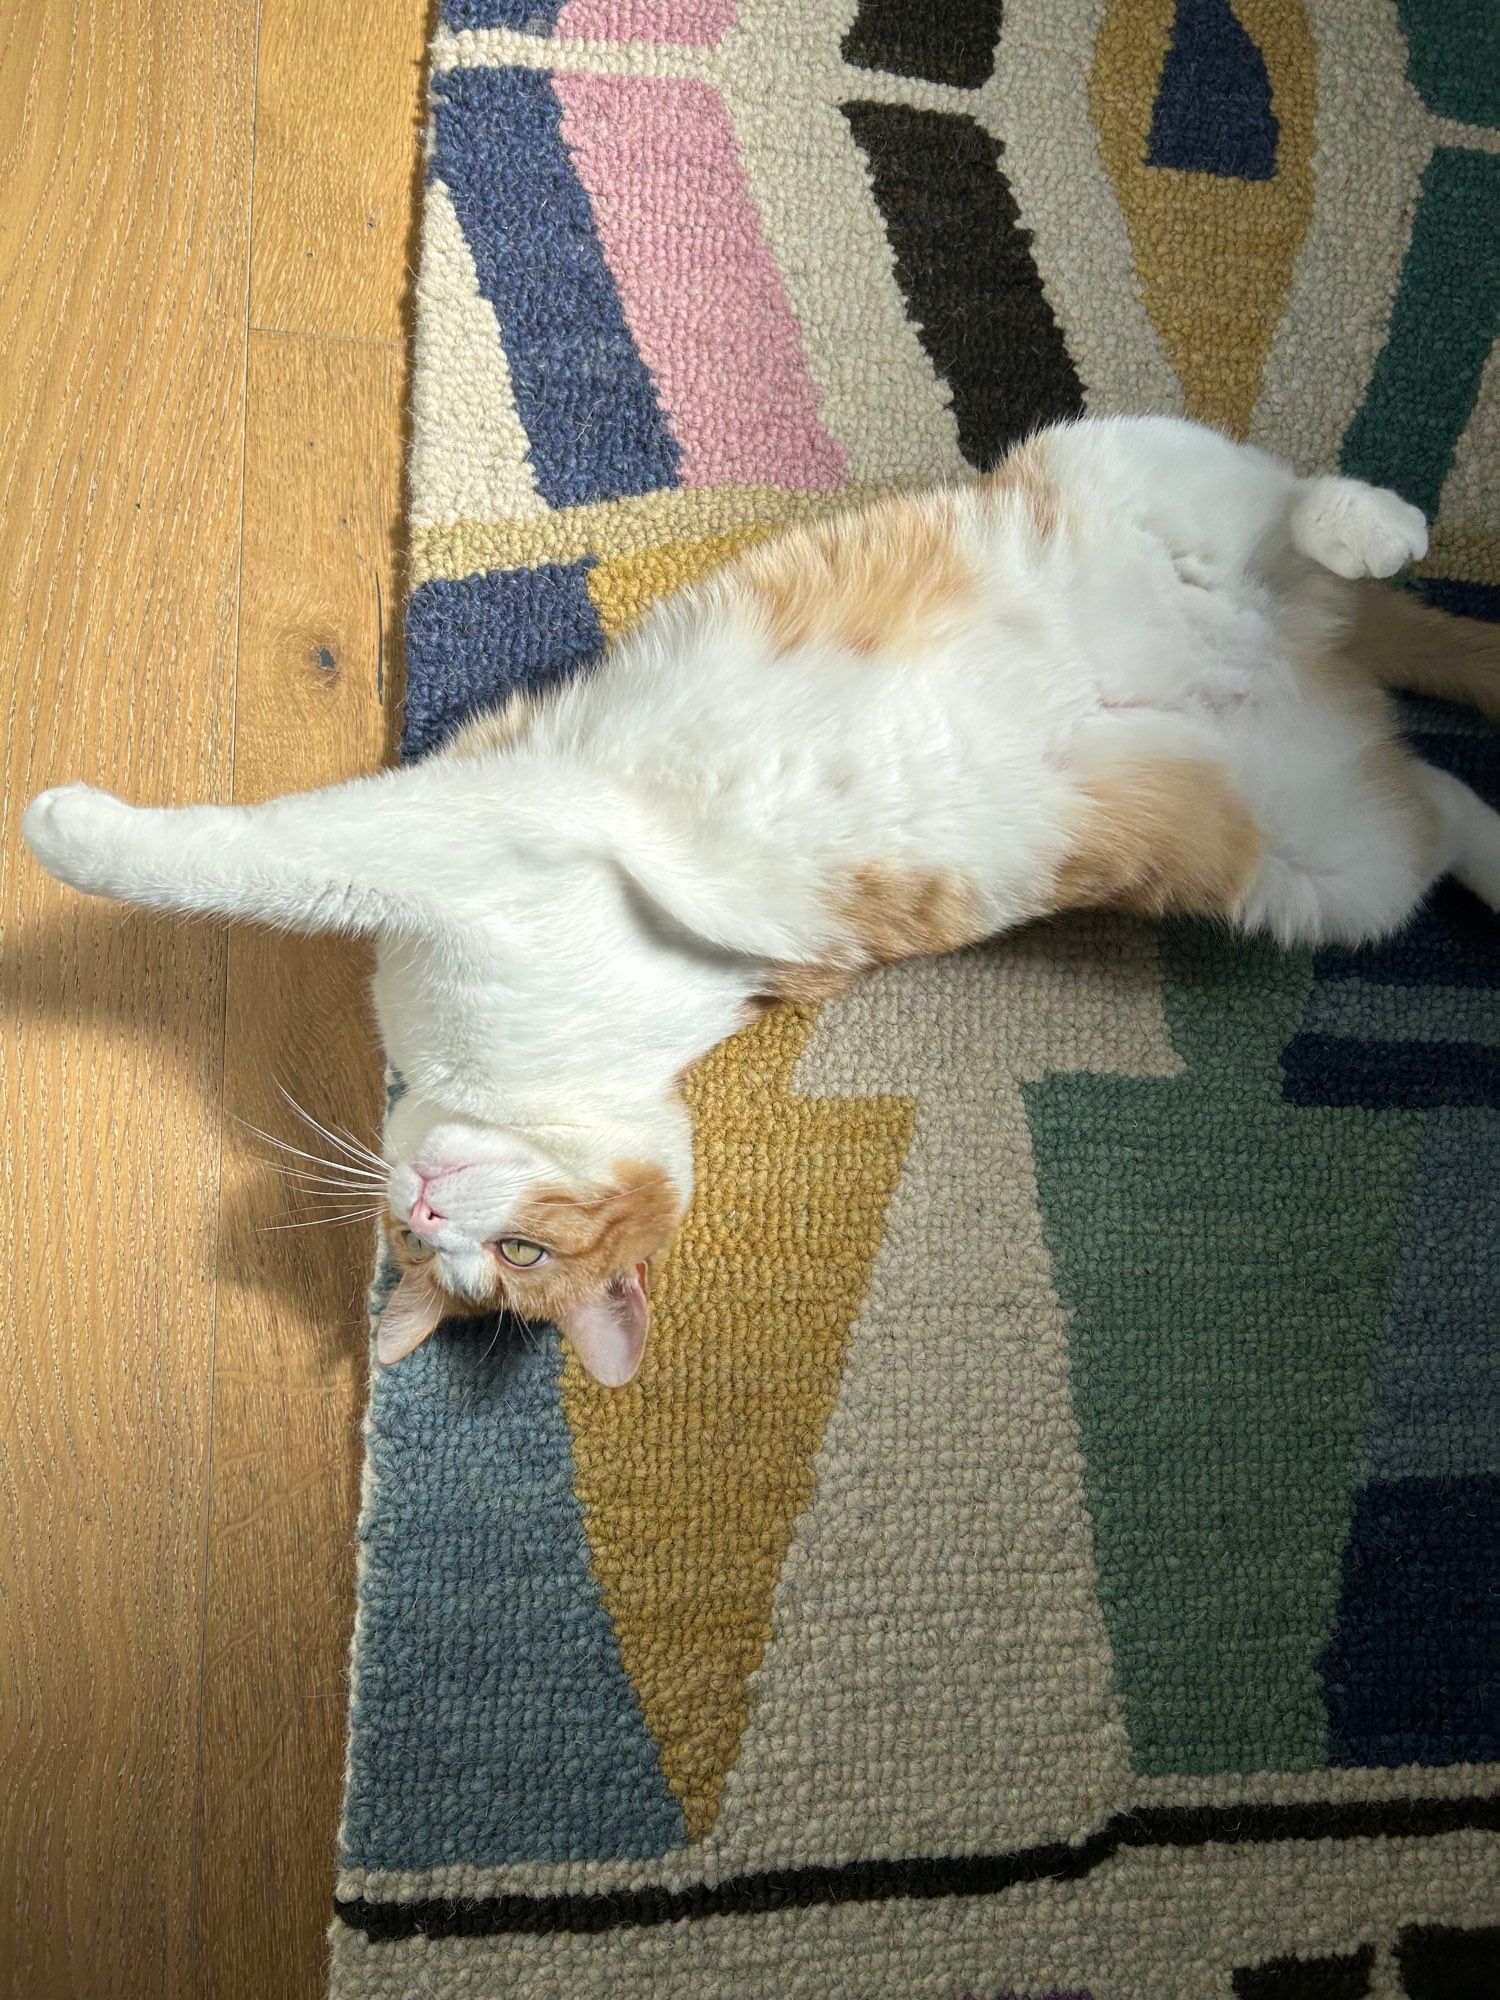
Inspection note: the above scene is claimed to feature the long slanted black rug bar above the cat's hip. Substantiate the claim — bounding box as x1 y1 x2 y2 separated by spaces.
844 104 1084 470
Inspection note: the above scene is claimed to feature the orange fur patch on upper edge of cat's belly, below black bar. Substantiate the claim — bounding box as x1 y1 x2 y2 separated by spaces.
730 492 974 658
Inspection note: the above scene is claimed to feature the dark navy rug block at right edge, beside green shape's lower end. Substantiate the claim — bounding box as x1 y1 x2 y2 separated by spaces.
1320 1474 1500 1766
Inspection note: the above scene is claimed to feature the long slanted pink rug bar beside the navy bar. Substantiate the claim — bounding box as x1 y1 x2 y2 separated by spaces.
552 72 848 492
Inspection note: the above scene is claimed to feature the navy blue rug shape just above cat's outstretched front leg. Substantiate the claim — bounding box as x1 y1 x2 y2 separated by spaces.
402 560 604 760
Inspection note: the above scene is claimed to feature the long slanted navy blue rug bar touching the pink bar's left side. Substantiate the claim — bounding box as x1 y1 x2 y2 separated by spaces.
430 68 682 506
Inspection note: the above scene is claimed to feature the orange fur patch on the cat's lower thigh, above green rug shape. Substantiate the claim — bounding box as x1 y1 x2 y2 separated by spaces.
1048 758 1264 916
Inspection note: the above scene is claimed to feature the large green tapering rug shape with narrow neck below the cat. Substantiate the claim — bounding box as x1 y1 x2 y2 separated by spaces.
1026 926 1424 1774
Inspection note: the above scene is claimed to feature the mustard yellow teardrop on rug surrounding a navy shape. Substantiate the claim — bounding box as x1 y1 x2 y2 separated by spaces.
1088 0 1318 438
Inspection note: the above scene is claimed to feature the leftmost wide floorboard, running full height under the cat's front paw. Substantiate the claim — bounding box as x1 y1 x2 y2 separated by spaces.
0 0 256 2000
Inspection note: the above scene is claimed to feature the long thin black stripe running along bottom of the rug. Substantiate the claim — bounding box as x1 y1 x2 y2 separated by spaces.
334 1796 1500 1944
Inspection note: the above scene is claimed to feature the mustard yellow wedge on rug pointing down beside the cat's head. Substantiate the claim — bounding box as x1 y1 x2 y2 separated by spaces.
562 1006 916 1840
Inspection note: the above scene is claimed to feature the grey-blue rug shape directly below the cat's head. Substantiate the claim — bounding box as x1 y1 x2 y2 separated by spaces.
342 1320 686 1868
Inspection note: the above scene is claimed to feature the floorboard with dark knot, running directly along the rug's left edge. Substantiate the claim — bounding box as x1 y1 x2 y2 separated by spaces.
198 334 402 2000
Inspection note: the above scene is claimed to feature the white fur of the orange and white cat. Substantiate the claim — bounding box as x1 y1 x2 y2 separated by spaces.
26 418 1500 1290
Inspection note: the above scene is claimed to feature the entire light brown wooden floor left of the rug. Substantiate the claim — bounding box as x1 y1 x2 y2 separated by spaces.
0 0 426 2000
